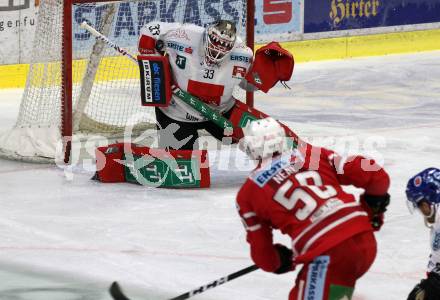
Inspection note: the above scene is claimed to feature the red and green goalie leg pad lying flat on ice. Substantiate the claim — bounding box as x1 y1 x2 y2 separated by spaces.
93 143 210 188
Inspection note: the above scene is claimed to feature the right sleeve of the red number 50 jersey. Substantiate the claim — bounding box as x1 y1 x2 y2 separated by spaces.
324 149 390 195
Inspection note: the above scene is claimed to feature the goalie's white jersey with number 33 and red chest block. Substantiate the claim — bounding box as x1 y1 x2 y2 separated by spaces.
140 22 253 122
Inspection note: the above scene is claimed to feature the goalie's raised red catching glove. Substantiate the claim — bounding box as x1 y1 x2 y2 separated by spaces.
245 42 295 93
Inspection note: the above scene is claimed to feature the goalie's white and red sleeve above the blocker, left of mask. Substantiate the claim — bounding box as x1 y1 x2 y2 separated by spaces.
138 22 181 54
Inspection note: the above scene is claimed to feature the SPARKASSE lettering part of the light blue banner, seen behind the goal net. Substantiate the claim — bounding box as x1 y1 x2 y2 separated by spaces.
73 0 246 49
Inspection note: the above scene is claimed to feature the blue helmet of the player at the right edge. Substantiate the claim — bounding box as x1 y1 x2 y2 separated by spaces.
406 168 440 212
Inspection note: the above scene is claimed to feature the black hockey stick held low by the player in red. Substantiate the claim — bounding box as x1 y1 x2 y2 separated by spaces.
109 265 259 300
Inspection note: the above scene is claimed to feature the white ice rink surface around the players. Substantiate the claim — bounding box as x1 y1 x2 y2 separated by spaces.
0 51 440 300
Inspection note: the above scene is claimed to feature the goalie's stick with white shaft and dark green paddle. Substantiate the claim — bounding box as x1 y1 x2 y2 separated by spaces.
80 21 233 134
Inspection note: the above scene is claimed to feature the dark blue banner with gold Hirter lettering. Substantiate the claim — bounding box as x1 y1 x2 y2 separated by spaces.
304 0 440 33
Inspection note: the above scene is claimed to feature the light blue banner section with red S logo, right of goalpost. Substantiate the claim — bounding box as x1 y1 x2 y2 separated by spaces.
255 0 302 35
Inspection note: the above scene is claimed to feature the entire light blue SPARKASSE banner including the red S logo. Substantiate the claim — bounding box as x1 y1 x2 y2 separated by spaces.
73 0 302 53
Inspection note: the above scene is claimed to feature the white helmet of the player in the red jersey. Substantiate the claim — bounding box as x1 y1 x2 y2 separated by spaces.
239 118 289 160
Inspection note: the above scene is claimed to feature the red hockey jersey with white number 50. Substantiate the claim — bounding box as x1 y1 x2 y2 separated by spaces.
237 145 389 272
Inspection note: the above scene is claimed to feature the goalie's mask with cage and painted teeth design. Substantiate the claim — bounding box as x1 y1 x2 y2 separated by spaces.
204 20 237 64
